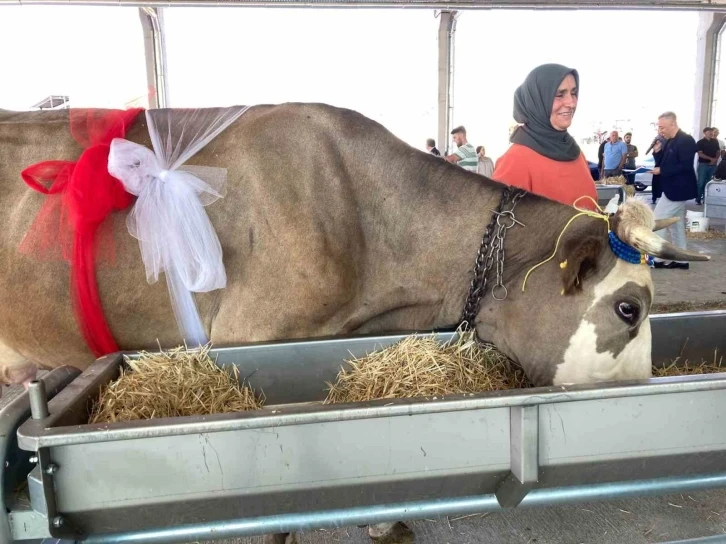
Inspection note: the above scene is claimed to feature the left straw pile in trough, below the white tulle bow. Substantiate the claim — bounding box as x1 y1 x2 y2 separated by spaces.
90 346 264 423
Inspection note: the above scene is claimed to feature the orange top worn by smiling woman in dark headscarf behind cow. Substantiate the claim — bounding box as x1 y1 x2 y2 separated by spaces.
492 144 597 210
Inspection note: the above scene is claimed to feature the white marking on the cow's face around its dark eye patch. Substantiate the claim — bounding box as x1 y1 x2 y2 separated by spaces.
553 259 653 385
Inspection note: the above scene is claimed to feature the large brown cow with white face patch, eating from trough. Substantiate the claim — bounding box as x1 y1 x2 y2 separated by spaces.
0 103 708 540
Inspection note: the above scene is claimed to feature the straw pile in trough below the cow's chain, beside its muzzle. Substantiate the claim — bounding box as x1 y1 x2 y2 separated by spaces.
325 332 529 404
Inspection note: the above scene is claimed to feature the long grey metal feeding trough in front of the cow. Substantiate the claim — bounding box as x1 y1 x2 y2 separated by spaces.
0 311 726 543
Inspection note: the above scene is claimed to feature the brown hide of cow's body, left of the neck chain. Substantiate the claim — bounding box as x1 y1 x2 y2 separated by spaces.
0 104 532 380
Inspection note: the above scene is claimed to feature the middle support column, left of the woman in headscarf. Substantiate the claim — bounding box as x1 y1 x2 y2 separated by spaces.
436 11 459 155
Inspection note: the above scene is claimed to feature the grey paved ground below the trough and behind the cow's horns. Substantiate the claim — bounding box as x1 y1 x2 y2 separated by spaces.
5 193 726 544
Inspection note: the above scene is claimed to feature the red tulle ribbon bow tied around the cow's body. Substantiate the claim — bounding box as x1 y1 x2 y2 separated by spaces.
20 108 143 357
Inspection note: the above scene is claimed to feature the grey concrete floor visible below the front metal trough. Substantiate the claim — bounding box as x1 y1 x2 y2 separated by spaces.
213 490 726 544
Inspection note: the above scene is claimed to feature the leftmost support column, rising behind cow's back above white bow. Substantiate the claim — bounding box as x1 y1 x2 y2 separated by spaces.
139 8 169 109
